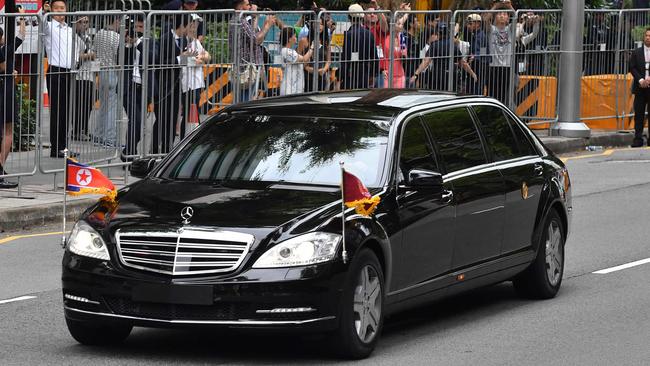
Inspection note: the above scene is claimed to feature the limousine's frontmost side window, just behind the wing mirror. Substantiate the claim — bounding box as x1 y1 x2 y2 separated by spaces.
399 119 438 180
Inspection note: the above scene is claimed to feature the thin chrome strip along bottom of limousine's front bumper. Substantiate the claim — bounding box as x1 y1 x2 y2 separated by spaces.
63 306 336 326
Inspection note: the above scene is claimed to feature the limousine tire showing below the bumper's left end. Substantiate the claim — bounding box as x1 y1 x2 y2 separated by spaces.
65 318 133 346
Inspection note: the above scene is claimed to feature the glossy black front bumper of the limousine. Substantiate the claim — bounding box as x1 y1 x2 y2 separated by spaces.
62 252 345 331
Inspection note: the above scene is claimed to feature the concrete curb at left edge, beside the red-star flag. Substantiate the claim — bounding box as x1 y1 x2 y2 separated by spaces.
0 199 97 232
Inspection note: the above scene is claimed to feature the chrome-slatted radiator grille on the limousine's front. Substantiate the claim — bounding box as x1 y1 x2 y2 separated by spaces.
115 226 255 276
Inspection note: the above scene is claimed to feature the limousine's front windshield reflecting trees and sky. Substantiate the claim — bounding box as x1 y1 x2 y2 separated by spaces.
158 115 388 187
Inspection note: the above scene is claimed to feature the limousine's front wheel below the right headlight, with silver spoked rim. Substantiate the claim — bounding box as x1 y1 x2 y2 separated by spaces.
331 249 385 360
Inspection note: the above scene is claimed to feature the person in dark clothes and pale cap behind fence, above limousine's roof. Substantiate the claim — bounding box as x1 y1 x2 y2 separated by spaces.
340 3 379 89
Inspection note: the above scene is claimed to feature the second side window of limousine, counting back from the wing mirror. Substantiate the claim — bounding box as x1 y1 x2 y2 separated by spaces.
422 108 486 173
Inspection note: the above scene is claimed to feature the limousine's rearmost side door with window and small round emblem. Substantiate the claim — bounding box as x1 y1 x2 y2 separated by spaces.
473 105 544 254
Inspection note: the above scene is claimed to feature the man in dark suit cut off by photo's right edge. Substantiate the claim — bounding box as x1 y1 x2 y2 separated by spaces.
629 28 650 147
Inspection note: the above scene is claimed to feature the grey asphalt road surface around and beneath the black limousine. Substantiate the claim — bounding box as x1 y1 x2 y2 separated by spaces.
0 149 650 365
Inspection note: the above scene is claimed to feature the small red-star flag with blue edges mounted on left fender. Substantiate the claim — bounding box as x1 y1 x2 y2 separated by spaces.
65 159 117 199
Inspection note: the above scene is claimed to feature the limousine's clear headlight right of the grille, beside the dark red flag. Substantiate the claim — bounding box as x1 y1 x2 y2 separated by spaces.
253 232 341 268
